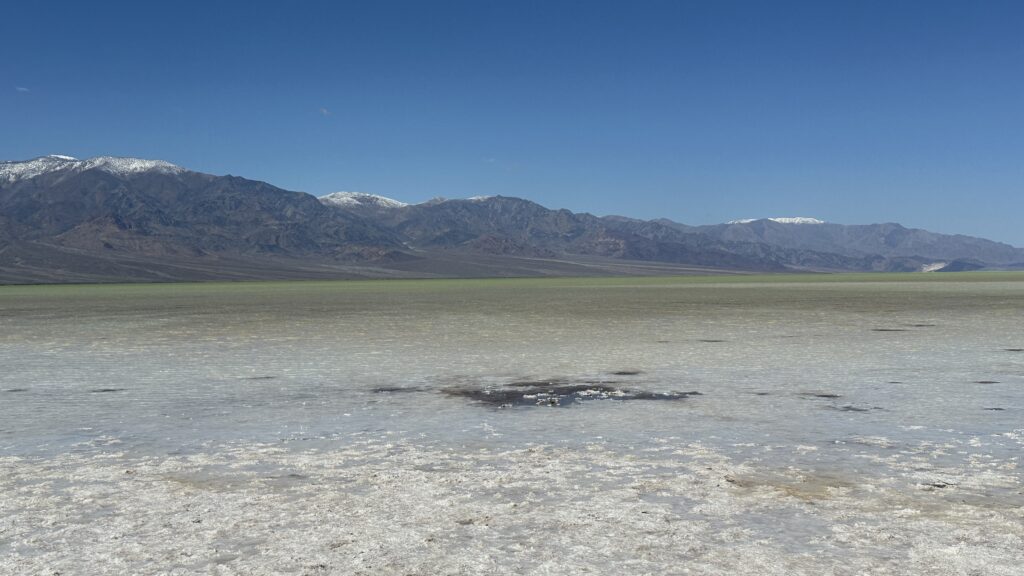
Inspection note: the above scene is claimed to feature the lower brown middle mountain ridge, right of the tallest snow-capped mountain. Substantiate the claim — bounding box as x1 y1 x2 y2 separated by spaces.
322 196 974 272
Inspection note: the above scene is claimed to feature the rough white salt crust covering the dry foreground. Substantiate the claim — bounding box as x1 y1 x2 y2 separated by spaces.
0 436 1024 576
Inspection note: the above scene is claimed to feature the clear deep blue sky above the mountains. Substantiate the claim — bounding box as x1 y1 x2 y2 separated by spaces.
0 0 1024 246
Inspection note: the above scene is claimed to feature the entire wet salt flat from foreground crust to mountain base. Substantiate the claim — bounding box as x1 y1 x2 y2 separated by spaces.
0 280 1024 574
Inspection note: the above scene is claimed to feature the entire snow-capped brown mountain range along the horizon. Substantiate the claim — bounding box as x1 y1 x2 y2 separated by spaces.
0 156 1024 284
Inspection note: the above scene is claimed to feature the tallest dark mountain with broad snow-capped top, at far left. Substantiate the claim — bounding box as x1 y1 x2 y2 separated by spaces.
0 157 401 280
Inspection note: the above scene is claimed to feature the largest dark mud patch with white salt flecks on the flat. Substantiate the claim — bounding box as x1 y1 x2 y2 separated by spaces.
441 381 700 408
